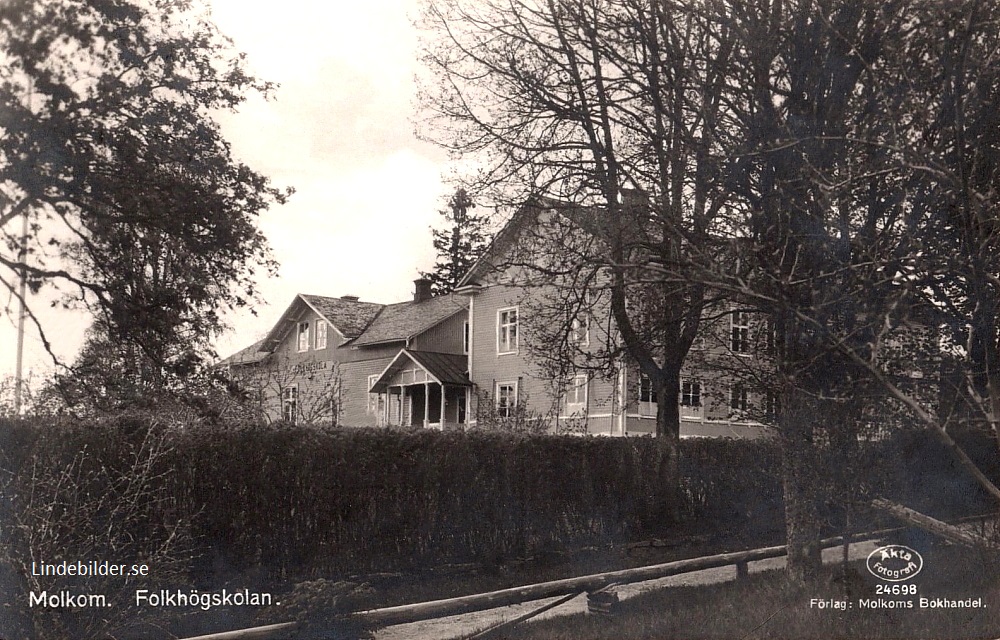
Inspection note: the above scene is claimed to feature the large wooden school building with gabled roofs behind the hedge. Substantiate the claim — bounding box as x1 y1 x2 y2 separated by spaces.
222 201 937 438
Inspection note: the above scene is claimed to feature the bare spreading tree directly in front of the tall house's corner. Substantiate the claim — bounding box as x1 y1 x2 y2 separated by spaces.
414 0 732 510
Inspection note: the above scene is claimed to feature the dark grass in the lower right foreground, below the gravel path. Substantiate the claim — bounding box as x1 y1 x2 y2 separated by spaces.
490 546 1000 640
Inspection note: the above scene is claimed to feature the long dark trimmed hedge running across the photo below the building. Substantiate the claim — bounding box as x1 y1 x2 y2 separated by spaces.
0 419 997 580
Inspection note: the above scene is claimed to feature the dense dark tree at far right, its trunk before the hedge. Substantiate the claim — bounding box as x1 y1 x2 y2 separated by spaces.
679 0 1000 580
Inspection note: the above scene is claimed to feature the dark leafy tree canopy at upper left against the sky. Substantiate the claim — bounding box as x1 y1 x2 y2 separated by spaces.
0 0 289 376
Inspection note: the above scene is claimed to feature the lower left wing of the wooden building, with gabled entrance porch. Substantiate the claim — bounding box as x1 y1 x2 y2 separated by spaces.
220 279 471 428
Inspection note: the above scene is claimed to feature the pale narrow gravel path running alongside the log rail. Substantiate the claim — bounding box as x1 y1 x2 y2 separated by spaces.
375 541 878 640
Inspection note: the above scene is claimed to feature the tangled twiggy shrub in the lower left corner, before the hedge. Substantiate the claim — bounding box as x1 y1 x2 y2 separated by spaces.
0 421 191 638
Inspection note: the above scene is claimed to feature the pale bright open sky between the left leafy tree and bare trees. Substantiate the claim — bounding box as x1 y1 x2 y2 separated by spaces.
0 0 452 377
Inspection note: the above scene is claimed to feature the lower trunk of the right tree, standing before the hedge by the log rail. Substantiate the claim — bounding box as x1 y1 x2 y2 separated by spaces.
779 389 822 584
